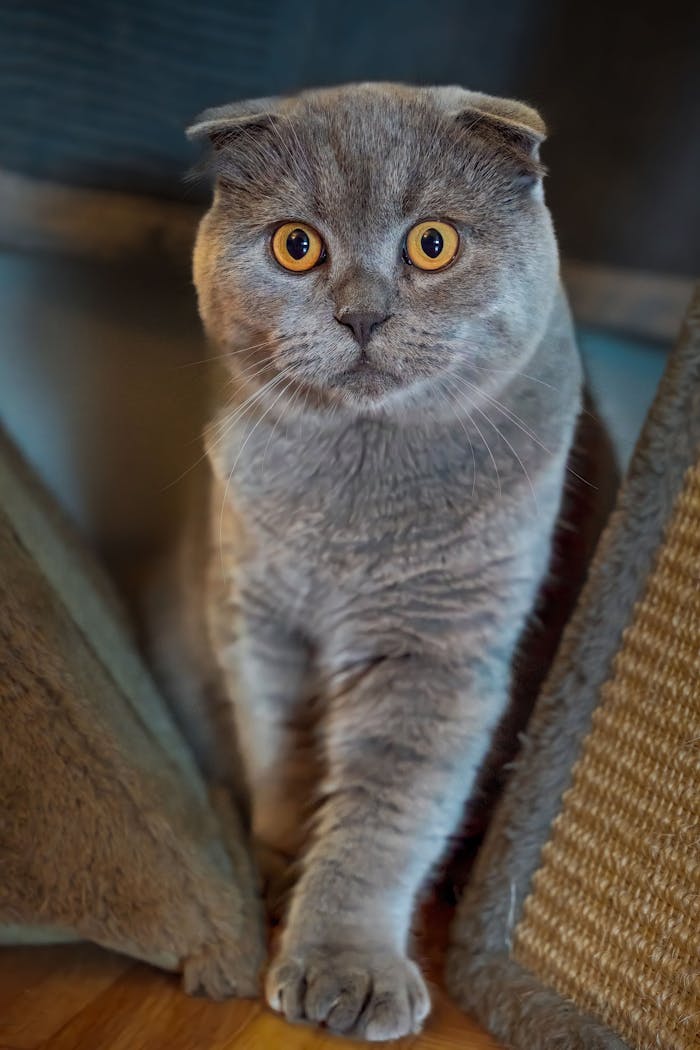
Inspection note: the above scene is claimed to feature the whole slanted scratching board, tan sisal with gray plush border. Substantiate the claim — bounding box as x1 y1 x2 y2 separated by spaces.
447 287 700 1050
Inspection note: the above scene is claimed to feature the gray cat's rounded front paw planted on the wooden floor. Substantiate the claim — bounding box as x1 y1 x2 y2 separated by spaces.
266 946 430 1041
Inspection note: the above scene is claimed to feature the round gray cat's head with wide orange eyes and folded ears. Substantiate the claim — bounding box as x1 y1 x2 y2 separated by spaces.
189 85 557 411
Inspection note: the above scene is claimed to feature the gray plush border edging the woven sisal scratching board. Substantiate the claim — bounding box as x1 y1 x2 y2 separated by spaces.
446 286 700 1050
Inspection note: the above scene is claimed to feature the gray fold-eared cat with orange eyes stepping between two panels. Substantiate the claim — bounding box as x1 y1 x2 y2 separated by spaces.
181 84 581 1040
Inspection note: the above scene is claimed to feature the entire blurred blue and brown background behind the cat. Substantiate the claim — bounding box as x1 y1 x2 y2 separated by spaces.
0 0 700 600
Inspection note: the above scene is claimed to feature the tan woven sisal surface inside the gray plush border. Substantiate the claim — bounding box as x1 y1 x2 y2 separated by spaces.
513 463 700 1050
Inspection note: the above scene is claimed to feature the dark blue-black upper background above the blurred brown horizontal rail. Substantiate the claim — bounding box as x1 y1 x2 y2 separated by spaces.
0 0 700 275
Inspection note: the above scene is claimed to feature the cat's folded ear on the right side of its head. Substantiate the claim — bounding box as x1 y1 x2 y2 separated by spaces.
433 87 547 179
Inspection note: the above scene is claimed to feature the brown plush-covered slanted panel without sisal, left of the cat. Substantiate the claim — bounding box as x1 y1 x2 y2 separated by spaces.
0 426 263 998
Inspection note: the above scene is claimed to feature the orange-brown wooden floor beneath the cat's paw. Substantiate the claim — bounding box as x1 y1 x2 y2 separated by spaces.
0 898 496 1050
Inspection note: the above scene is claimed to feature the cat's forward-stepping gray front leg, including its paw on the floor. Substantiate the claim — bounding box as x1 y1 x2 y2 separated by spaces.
267 656 506 1040
